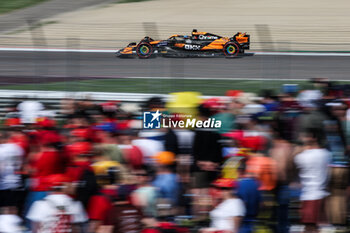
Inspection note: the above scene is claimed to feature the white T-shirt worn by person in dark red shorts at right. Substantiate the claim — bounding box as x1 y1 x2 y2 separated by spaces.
294 149 331 201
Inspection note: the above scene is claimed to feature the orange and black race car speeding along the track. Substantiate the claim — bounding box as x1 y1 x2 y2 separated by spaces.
116 29 250 58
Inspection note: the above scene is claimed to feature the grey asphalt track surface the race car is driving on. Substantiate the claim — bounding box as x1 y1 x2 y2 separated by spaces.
0 51 350 84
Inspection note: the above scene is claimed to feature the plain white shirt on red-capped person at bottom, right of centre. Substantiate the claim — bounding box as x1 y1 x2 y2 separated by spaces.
210 198 246 231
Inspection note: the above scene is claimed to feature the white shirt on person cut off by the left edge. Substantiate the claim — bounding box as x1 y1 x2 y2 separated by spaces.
0 143 24 190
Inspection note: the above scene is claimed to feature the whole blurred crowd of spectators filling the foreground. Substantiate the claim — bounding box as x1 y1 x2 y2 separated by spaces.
0 79 350 233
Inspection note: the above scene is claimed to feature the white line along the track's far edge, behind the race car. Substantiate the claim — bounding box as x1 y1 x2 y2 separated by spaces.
0 47 350 57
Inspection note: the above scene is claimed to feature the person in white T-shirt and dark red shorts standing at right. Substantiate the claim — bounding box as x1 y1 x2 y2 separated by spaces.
294 128 331 232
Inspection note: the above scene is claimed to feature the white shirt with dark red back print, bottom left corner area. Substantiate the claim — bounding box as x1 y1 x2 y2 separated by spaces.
27 194 87 233
